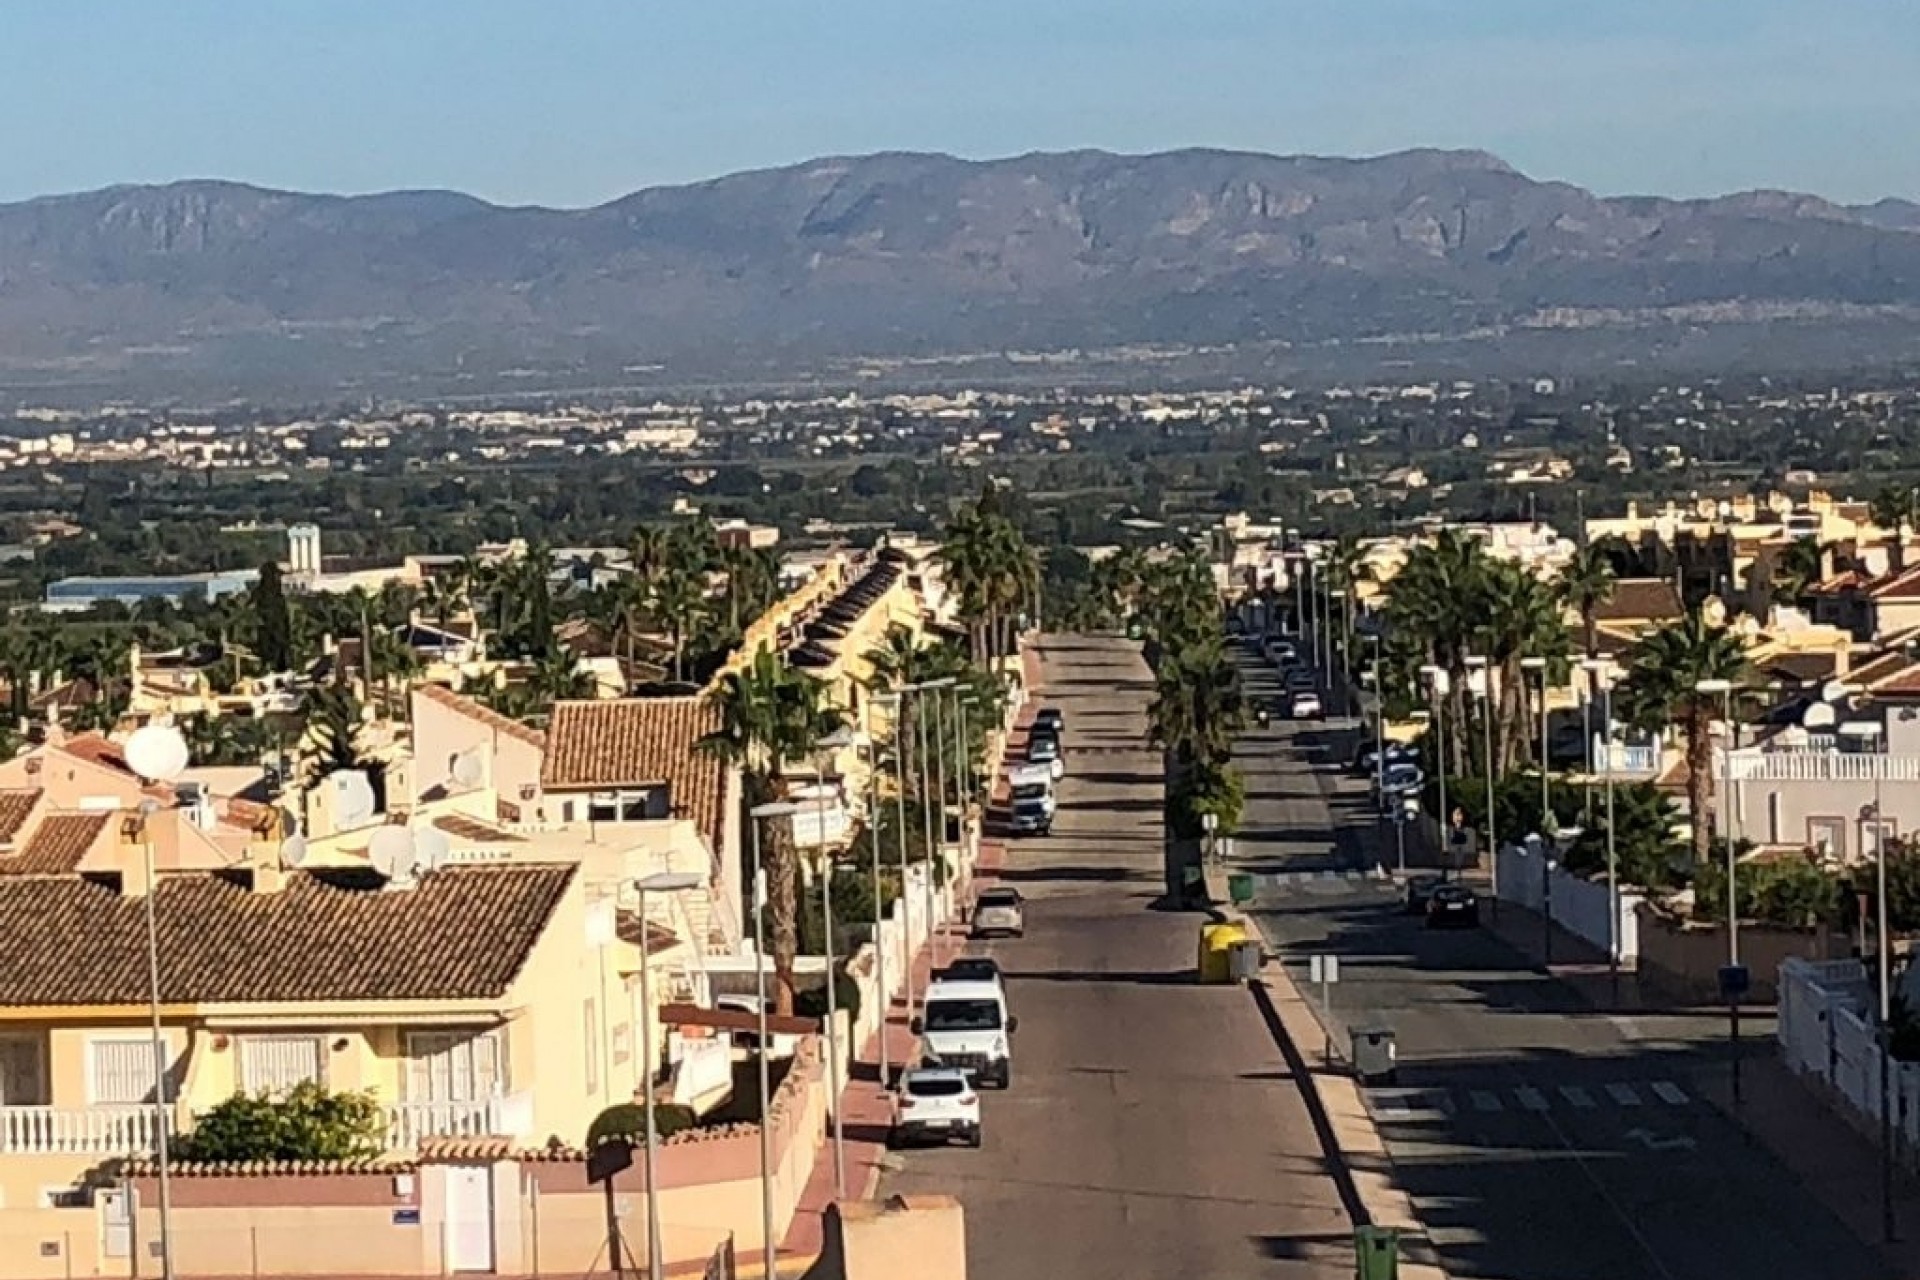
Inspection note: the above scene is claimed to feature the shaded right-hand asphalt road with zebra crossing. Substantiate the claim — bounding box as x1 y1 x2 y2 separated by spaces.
1236 652 1882 1280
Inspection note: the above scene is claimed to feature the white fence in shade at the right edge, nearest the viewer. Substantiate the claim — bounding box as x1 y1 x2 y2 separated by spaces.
1774 960 1920 1165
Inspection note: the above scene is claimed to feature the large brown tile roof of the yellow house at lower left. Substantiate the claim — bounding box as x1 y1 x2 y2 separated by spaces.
0 864 576 1007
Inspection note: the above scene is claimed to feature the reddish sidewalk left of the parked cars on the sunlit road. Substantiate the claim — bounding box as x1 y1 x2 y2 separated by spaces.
780 667 1039 1272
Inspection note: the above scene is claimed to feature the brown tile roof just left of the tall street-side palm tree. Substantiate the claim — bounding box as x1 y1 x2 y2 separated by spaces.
540 695 726 850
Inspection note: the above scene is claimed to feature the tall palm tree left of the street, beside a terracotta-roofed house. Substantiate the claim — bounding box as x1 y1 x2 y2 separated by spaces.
699 645 839 1017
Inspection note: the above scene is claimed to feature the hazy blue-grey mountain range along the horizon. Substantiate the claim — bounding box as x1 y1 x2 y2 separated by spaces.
0 150 1920 390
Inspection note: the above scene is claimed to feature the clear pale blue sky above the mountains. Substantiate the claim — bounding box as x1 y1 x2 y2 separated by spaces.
0 0 1920 205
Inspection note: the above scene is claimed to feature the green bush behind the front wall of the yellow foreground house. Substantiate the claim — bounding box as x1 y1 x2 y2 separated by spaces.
173 1084 386 1165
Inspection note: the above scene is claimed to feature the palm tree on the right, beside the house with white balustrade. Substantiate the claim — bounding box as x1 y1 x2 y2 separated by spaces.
1615 606 1747 860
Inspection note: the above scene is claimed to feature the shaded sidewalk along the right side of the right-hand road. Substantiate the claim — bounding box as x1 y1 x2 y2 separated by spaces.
1482 902 1920 1280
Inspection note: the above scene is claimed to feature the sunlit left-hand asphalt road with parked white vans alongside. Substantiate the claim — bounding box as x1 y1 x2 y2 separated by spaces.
881 637 1352 1280
